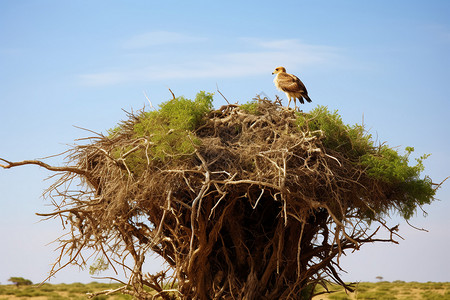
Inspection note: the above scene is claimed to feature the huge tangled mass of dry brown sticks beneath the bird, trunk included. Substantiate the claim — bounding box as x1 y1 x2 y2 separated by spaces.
2 99 432 299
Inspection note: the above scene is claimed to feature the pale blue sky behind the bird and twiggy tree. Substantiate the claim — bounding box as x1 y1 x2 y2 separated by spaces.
0 0 450 283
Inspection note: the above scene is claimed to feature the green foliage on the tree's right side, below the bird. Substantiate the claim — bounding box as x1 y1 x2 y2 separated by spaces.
297 106 435 219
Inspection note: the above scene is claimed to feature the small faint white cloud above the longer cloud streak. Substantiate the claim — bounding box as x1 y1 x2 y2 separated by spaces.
122 30 206 49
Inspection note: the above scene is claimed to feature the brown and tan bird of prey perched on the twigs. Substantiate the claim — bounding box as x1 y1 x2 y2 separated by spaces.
272 67 311 109
